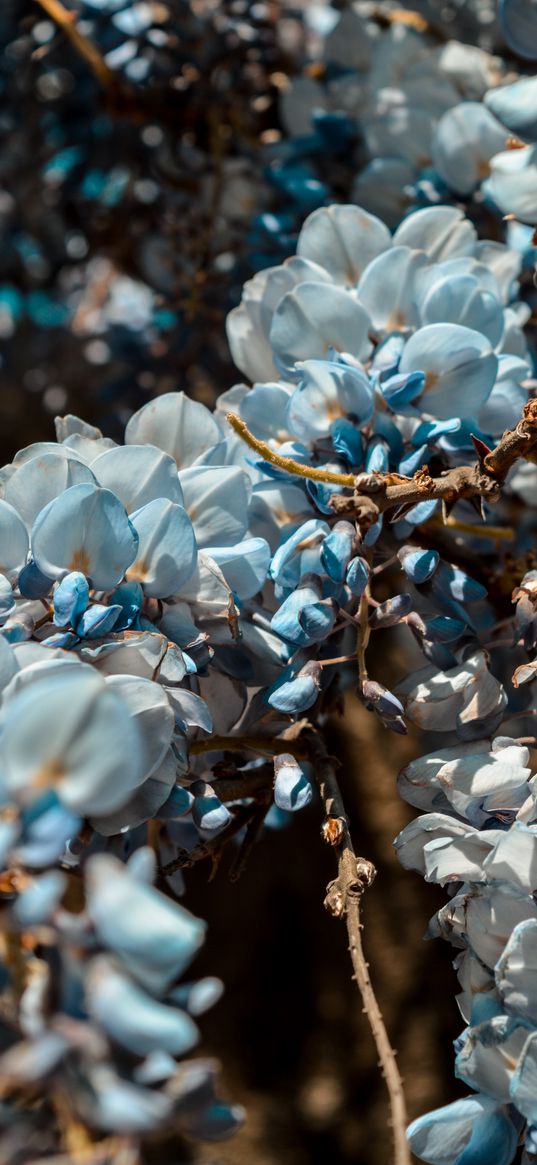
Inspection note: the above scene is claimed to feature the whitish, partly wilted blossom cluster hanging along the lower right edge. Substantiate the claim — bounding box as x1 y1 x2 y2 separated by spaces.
395 571 537 1165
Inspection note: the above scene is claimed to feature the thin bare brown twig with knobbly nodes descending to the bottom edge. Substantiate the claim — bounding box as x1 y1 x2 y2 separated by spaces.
308 733 411 1165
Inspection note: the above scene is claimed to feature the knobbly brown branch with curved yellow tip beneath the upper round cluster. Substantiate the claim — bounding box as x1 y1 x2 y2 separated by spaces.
227 397 537 527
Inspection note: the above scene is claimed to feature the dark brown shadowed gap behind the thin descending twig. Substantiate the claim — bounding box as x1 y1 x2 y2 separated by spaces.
182 698 465 1165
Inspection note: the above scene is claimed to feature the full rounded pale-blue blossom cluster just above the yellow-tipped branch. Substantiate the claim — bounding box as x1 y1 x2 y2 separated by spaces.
225 206 531 489
